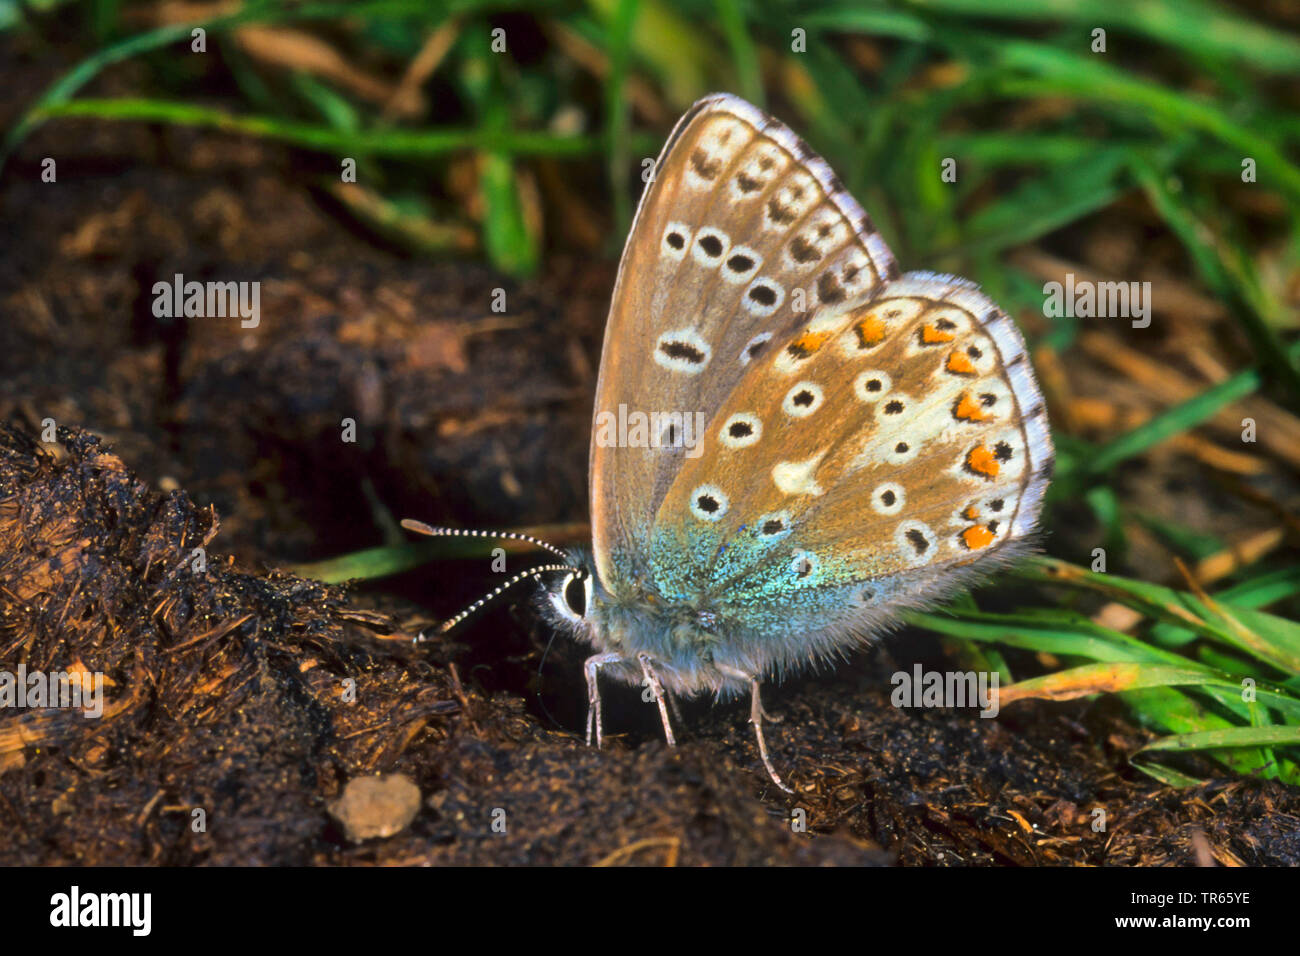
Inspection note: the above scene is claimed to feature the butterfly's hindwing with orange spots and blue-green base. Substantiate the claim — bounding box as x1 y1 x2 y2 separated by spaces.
654 273 1053 631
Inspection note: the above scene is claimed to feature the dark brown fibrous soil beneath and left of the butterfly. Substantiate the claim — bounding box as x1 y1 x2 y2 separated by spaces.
0 46 1300 865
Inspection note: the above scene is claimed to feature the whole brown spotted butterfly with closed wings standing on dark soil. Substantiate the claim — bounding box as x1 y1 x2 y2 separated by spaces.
406 94 1053 791
